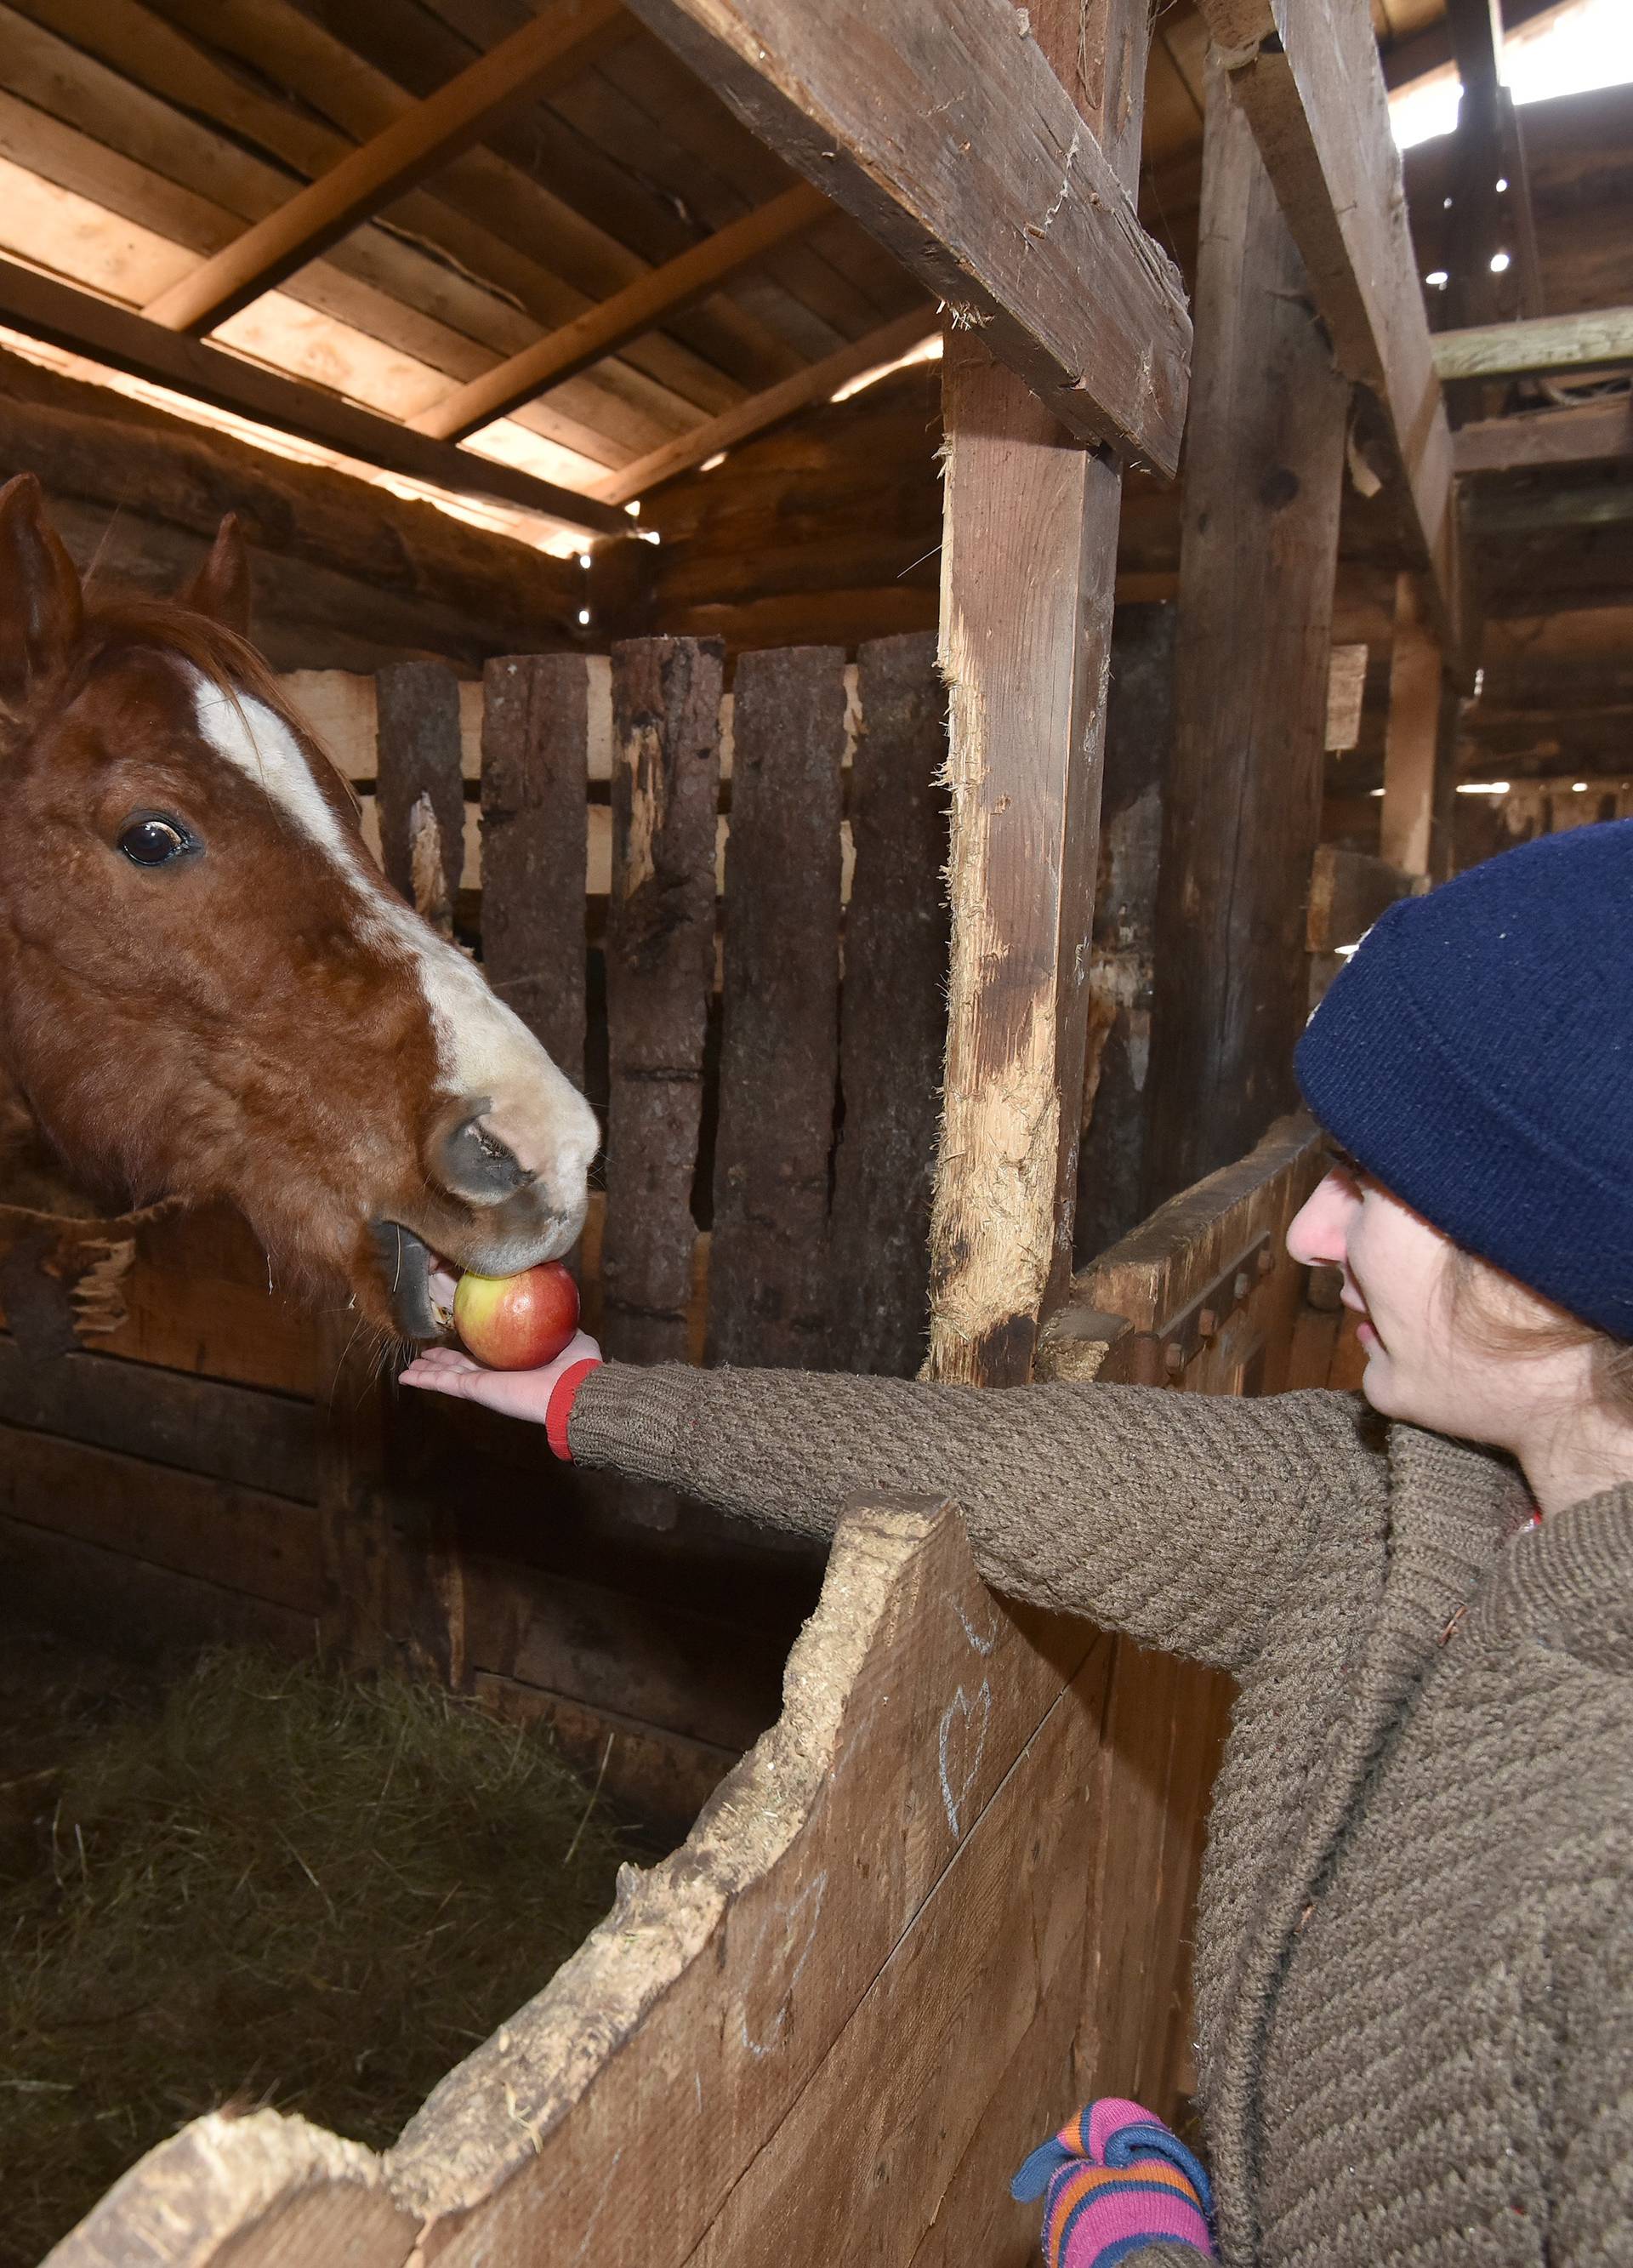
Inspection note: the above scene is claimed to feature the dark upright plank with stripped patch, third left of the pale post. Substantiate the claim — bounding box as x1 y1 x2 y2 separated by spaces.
601 637 721 1363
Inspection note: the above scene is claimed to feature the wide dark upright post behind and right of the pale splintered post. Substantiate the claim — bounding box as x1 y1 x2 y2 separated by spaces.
1146 61 1350 1206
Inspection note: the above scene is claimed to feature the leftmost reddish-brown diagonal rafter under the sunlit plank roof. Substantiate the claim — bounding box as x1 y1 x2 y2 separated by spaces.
143 0 629 336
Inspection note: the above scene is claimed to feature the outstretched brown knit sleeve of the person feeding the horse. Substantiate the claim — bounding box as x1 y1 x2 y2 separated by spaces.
567 1363 1385 1669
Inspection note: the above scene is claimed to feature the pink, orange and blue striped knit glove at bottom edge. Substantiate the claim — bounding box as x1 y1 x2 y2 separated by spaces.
1010 2095 1214 2268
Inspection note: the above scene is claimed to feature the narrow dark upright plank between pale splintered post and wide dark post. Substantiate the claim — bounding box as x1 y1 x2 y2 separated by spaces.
1073 603 1177 1266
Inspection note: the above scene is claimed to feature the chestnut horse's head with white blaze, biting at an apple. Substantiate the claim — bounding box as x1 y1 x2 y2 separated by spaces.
0 476 596 1338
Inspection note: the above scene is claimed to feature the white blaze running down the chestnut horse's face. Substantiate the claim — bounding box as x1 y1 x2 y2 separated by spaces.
188 669 601 1220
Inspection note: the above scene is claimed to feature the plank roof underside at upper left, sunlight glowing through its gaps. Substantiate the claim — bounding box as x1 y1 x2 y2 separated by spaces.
0 0 1524 539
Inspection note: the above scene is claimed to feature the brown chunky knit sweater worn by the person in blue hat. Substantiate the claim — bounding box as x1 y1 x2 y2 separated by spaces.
569 1365 1633 2268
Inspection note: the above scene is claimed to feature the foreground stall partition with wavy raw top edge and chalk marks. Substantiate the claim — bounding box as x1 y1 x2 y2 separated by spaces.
50 1497 1111 2268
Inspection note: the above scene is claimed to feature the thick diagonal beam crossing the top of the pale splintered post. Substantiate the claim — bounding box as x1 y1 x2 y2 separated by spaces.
617 0 1191 474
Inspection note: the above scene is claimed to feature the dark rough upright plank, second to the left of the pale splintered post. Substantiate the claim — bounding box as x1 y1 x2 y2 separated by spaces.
705 647 846 1368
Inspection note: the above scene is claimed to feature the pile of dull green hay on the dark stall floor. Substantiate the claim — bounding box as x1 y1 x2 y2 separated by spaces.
0 1651 623 2268
